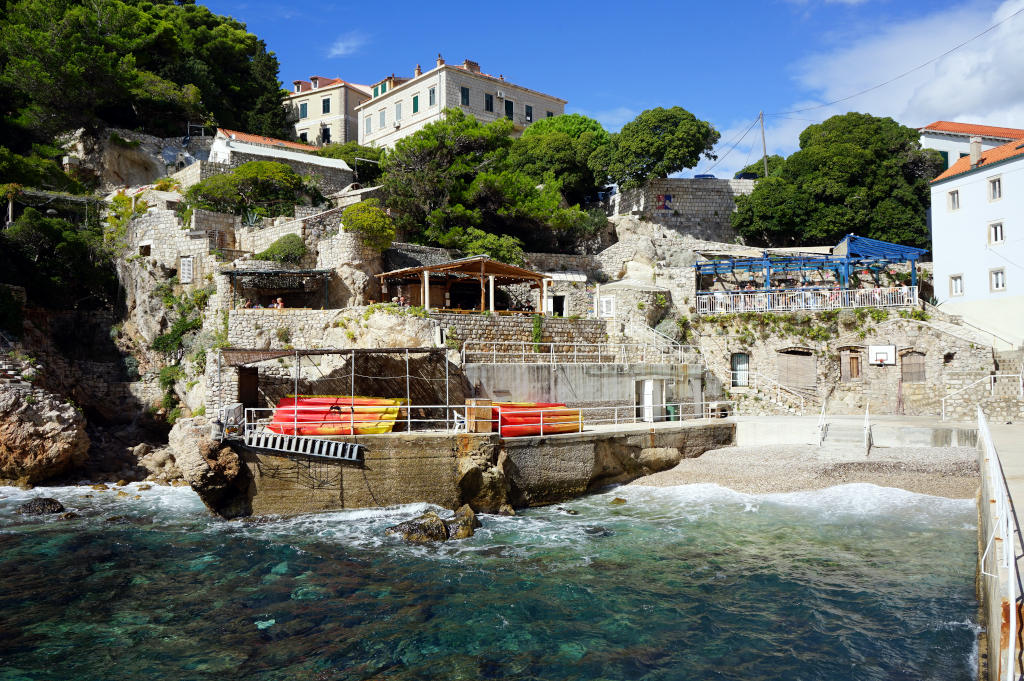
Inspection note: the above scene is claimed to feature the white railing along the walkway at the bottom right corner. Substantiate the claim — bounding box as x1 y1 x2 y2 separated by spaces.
978 406 1020 681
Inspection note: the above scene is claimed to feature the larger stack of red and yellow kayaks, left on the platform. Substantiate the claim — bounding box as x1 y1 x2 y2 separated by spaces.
267 395 406 436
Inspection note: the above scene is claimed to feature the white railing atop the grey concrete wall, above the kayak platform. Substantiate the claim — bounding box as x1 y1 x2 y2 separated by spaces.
462 340 700 365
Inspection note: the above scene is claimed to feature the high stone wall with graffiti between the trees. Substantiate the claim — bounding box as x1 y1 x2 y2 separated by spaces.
609 178 756 242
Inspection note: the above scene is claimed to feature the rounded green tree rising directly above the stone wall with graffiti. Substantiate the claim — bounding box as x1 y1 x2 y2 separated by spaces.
608 107 720 189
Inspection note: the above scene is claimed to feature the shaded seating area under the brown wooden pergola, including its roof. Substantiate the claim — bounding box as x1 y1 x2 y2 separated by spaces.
377 255 548 314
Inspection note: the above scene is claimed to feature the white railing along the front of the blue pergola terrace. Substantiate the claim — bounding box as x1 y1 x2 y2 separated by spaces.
696 286 918 314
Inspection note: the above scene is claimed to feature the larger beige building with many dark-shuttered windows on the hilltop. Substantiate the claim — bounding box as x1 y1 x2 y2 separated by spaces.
355 54 566 147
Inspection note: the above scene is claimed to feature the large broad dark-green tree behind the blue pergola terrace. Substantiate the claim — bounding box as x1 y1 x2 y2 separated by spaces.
732 113 942 248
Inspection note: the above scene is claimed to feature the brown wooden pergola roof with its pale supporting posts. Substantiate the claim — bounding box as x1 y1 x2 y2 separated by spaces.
377 255 548 313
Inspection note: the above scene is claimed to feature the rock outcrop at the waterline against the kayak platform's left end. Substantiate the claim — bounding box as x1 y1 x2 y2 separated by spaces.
168 417 252 518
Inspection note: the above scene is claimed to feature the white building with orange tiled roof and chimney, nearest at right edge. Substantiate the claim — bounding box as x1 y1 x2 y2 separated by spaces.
931 137 1024 346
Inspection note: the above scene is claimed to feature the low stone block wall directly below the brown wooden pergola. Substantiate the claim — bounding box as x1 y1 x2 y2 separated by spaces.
430 312 608 344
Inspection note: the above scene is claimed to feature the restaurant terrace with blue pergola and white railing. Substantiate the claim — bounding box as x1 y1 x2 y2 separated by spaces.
693 235 927 314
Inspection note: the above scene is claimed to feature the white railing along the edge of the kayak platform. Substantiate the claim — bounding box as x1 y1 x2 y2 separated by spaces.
235 400 735 439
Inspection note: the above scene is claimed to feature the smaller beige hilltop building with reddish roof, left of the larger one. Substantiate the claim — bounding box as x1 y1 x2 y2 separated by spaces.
286 76 370 144
